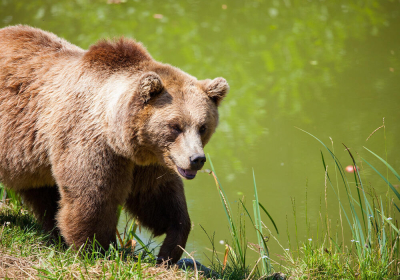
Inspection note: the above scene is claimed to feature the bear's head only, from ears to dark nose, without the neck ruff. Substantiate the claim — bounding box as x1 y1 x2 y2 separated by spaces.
132 65 229 179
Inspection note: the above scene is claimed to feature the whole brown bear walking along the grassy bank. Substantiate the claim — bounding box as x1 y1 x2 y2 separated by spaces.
0 25 229 263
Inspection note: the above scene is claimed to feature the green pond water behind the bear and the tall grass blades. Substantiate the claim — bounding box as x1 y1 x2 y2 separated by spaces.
0 0 400 261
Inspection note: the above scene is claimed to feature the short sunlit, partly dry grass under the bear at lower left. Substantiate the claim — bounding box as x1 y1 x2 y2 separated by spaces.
0 192 203 279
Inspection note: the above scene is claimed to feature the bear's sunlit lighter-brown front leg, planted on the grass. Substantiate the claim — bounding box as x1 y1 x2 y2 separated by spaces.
53 145 132 250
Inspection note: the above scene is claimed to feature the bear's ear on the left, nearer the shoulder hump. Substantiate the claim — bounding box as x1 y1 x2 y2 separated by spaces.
139 72 164 103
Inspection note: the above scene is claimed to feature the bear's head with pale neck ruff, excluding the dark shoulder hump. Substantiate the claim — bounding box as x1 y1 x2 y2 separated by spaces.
109 63 229 179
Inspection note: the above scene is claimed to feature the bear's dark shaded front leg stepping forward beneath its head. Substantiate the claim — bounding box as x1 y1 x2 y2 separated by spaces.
125 166 191 264
